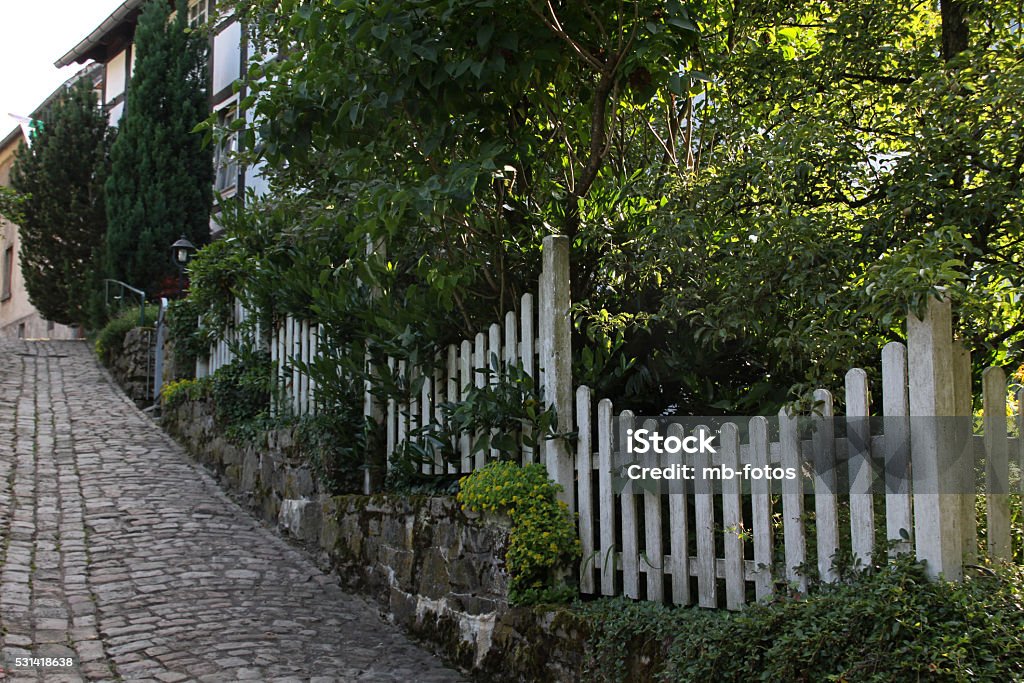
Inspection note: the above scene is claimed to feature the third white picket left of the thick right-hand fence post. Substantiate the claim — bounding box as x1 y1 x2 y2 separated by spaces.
811 389 839 583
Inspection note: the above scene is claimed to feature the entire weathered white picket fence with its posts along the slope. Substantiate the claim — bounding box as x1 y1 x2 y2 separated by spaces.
195 237 1024 609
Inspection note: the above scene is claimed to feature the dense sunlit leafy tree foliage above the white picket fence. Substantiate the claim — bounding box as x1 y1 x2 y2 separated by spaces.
190 0 1024 415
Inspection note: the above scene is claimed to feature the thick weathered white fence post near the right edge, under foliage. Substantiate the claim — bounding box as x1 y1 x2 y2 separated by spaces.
906 298 964 581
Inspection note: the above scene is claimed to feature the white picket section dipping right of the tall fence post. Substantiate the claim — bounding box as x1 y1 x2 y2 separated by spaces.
575 333 1024 609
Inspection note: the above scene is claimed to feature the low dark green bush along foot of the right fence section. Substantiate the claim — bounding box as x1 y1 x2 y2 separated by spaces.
581 559 1024 683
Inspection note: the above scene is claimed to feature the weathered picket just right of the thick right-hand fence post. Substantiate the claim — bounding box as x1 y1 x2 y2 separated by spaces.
981 368 1013 560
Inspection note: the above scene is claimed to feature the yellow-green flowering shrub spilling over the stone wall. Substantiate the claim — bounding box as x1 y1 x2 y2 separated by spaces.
458 461 580 604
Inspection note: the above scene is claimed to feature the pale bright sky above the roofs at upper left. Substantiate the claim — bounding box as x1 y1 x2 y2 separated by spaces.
0 0 123 137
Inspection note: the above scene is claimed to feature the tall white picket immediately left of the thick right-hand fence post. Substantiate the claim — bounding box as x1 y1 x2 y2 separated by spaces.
882 342 913 555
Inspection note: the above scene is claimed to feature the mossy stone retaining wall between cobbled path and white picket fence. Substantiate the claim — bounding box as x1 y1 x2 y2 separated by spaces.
162 401 585 681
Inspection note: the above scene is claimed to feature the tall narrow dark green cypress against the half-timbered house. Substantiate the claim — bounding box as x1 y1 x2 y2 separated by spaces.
106 0 213 295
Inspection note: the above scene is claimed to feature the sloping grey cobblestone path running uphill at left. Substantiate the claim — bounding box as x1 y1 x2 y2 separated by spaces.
0 341 460 683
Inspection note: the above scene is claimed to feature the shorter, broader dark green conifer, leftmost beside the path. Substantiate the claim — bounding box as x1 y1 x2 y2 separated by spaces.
3 79 110 325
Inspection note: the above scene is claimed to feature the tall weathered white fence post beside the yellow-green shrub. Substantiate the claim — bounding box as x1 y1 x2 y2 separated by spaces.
539 234 573 508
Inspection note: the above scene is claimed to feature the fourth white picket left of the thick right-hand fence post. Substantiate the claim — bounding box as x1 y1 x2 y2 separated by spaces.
778 408 807 593
